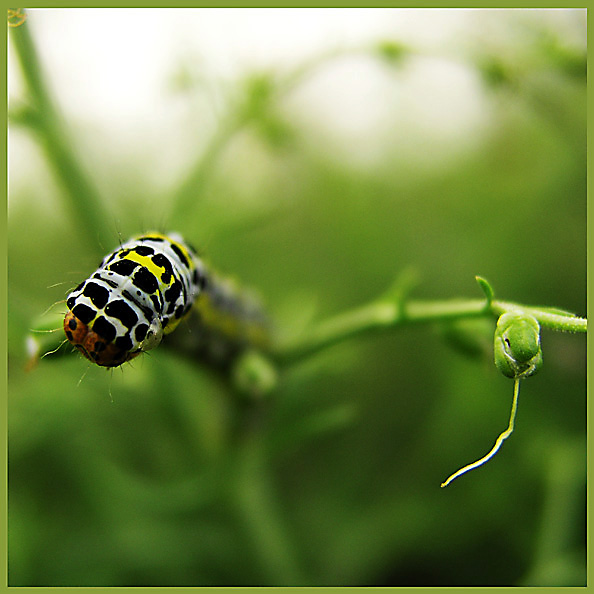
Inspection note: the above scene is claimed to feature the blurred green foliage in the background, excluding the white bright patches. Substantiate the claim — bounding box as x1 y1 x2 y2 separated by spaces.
8 11 586 586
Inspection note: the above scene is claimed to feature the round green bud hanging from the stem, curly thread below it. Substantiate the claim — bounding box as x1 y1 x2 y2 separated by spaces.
494 312 542 379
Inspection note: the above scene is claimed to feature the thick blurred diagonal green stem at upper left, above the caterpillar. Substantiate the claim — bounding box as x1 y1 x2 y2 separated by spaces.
10 15 113 246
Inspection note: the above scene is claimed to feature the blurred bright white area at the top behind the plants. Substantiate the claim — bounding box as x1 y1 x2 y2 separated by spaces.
9 8 586 194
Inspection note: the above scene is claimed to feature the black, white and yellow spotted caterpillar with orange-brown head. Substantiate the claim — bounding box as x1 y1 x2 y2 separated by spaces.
64 232 269 367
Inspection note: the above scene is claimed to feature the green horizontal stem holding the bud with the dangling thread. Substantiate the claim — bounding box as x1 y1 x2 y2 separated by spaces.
273 299 587 365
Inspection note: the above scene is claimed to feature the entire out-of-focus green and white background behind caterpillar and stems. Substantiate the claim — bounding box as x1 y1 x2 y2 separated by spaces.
8 9 586 586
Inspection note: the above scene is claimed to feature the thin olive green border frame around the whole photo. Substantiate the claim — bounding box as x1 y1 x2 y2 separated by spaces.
0 0 594 594
